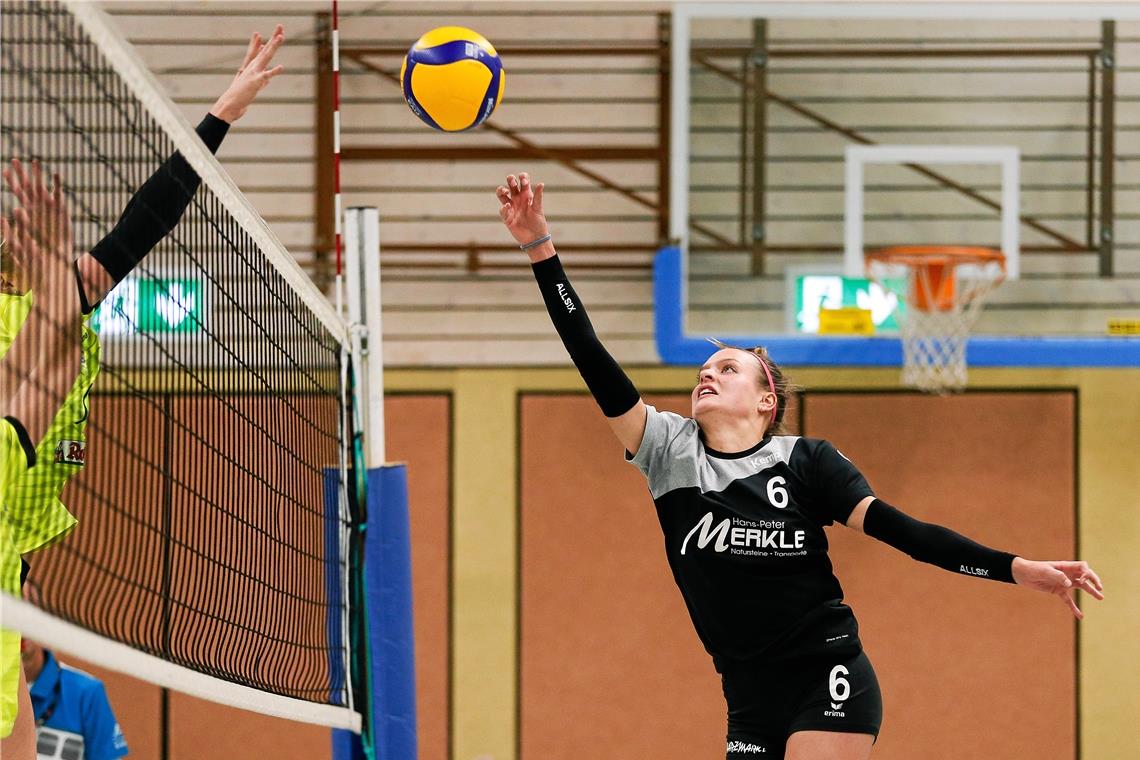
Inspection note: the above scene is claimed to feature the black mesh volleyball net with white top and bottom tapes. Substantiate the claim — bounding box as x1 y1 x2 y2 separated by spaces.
0 2 361 730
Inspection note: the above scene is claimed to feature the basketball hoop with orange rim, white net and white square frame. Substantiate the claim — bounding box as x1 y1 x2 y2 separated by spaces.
844 145 1020 393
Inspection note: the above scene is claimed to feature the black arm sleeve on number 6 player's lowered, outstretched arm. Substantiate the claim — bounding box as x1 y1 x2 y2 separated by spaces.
863 499 1013 583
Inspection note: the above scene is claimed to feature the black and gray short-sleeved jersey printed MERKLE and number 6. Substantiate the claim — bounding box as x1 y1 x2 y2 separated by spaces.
627 407 873 672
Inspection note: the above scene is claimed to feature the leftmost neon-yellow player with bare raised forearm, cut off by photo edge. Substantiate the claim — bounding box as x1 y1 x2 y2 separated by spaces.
0 165 80 760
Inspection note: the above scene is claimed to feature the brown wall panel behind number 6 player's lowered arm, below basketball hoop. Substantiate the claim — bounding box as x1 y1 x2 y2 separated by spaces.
804 391 1077 760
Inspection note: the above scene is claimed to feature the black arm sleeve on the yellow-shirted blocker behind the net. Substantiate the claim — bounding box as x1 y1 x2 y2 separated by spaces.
91 114 229 291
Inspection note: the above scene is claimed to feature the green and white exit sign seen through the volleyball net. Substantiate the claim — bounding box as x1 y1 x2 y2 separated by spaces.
90 277 206 335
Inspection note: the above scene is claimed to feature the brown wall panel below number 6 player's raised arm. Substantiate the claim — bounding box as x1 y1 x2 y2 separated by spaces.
519 394 725 760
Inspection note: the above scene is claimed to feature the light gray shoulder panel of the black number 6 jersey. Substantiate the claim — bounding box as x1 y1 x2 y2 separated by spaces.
630 407 799 499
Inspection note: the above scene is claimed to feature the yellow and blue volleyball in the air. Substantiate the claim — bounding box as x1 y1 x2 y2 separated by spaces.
400 26 506 132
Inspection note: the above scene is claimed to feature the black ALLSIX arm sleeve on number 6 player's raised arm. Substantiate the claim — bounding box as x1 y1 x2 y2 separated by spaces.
531 256 641 417
